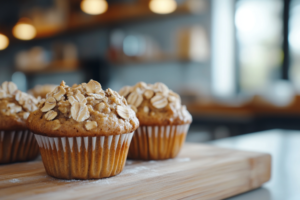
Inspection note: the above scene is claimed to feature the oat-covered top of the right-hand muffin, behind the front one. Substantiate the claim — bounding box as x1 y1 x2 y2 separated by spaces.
119 82 192 126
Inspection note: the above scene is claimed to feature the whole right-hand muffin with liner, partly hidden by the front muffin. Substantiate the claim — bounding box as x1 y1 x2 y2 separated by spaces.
119 82 192 160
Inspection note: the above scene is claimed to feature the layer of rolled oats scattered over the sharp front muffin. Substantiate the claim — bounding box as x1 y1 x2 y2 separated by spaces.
36 80 138 131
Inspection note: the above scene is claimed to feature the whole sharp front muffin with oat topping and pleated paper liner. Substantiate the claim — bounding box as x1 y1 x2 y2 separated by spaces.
27 80 139 179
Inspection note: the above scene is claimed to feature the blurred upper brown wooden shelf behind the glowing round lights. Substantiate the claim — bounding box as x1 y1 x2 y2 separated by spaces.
6 1 202 43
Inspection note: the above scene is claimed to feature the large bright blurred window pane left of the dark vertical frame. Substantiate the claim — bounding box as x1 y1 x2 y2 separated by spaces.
235 0 282 93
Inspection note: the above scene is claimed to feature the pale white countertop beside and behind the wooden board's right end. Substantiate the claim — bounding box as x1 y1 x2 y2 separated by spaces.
209 130 300 200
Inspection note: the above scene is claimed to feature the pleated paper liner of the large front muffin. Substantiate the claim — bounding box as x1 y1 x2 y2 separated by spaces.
35 132 133 179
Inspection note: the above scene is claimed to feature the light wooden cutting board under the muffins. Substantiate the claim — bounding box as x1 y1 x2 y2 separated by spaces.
0 143 271 200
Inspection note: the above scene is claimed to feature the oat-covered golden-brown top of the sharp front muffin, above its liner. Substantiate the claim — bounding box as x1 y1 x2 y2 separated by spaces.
27 80 139 137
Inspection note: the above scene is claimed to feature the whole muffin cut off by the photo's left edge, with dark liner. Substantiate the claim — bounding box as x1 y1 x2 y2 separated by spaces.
0 82 39 163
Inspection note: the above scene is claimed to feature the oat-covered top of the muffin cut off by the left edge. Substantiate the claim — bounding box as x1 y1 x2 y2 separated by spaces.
0 82 38 130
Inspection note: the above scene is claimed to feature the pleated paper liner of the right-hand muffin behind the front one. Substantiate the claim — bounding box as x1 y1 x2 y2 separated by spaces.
128 124 190 160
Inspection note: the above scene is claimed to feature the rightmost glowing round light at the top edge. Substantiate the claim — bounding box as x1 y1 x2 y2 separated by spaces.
149 0 177 14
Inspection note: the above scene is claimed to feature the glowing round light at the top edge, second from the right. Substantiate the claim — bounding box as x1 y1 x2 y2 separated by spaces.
80 0 108 15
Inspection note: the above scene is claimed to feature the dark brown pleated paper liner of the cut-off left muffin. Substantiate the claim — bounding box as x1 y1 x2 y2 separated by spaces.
0 130 39 163
